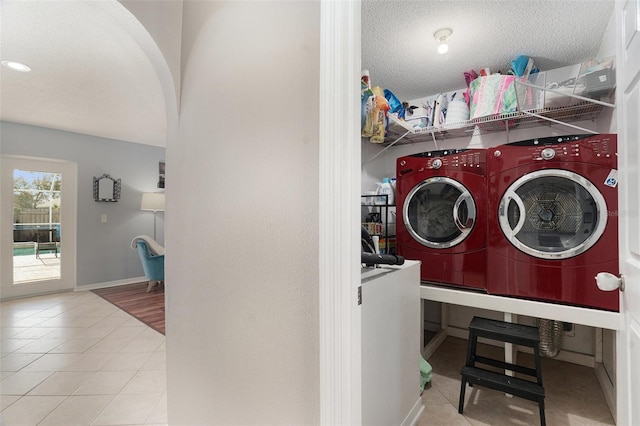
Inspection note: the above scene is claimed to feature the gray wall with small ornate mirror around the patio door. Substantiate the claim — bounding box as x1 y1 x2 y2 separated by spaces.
0 122 165 286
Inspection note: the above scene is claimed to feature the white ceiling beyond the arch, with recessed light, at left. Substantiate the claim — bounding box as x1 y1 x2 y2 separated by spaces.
0 0 167 146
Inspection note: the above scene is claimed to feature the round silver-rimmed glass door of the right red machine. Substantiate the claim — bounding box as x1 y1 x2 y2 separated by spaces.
498 169 607 259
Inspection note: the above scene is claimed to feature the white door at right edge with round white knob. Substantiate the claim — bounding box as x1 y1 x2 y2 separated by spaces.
616 0 640 425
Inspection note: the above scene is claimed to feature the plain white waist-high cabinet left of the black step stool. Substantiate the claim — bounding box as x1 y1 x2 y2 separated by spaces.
361 261 424 426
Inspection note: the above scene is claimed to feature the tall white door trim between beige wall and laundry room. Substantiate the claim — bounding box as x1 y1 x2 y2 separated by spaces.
319 0 362 425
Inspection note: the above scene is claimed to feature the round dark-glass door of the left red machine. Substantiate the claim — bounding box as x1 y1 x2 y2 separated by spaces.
402 177 476 249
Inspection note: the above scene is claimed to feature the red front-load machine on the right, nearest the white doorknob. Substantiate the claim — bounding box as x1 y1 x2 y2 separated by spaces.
487 134 619 311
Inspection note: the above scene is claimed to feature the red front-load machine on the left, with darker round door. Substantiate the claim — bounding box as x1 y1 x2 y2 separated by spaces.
396 149 487 290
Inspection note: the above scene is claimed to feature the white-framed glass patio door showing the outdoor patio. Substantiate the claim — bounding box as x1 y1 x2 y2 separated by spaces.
0 156 77 299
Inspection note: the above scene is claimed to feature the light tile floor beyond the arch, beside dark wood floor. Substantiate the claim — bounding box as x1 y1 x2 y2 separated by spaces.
0 291 167 426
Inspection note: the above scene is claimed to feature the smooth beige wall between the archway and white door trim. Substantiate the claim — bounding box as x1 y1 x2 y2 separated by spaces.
166 1 320 425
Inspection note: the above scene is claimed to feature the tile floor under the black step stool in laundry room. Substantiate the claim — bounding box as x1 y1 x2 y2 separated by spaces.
418 337 615 426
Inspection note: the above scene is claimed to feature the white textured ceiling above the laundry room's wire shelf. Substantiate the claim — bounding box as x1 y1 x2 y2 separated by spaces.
362 0 614 101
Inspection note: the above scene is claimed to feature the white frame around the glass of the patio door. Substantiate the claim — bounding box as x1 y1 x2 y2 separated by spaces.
0 155 78 300
